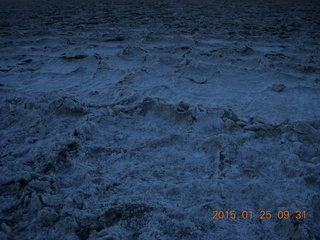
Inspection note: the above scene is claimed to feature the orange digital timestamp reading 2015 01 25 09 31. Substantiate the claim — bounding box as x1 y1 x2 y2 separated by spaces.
212 210 307 220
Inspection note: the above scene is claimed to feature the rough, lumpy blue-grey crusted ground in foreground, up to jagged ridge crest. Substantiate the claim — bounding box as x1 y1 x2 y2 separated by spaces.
1 92 320 239
